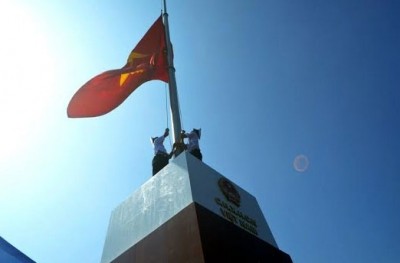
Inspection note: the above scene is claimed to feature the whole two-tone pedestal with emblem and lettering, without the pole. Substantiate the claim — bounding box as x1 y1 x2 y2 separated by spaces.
101 152 292 263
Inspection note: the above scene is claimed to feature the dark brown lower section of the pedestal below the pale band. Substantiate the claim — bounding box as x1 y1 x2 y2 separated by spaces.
112 203 292 263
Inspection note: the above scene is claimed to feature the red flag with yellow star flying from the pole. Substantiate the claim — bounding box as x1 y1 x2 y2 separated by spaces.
67 16 169 118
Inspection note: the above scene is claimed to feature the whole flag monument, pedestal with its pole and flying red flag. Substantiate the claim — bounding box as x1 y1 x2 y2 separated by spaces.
67 0 292 263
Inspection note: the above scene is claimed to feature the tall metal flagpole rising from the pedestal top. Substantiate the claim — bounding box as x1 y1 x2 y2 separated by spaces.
163 0 182 156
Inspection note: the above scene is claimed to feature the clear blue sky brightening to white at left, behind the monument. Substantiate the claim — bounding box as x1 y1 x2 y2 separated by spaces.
0 0 400 263
